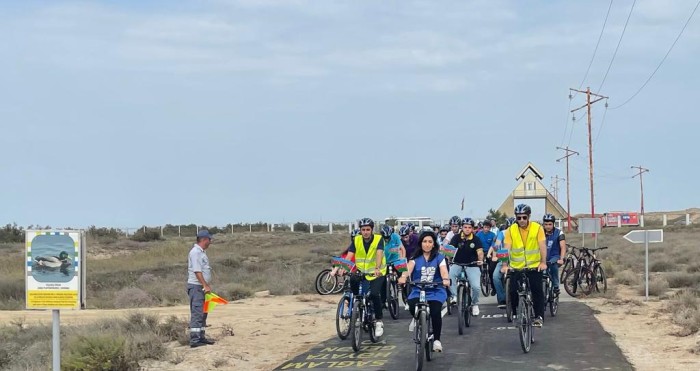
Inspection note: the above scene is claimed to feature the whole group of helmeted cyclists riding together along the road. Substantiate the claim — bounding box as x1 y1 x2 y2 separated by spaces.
331 204 566 352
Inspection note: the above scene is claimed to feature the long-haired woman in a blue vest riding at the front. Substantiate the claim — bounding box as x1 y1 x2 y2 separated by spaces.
399 231 450 352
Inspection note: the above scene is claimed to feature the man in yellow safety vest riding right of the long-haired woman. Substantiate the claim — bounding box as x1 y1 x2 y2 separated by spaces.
501 204 547 327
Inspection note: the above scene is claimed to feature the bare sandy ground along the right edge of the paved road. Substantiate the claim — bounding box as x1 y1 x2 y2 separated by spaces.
583 285 700 371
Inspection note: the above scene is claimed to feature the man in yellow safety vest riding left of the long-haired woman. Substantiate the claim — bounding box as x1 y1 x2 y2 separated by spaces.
347 218 386 337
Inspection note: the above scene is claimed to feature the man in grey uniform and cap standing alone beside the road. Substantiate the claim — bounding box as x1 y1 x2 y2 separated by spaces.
187 229 214 348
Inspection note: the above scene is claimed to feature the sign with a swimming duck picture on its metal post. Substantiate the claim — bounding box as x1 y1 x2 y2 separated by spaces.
24 230 86 371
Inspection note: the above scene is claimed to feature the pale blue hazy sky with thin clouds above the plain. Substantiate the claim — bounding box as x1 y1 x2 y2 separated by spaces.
0 0 700 227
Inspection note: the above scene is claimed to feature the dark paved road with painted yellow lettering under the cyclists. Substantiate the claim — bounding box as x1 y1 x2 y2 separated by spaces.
276 297 633 371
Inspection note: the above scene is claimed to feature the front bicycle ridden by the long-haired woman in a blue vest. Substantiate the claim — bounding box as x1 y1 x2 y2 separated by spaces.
409 282 442 371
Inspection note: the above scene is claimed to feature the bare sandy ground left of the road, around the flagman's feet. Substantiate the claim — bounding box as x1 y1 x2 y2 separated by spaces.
0 295 339 370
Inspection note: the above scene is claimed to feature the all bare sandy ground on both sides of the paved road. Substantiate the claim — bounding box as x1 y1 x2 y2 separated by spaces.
0 286 700 371
